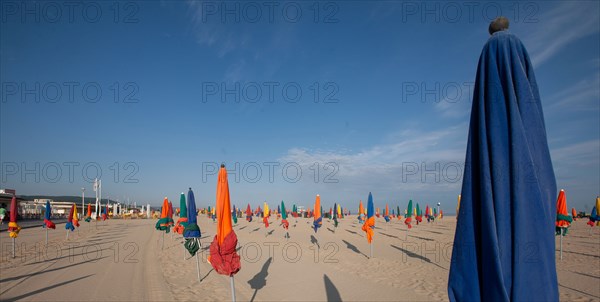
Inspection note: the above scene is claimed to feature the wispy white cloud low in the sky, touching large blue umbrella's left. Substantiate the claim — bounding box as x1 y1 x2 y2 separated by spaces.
280 123 467 201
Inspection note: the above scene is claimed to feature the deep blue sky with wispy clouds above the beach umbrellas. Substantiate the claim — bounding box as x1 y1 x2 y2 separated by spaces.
0 1 600 213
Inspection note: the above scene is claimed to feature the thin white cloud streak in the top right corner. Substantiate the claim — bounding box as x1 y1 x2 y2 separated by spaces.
522 1 600 66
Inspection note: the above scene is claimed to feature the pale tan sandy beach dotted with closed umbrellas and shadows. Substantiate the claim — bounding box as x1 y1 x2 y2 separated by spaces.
0 215 600 301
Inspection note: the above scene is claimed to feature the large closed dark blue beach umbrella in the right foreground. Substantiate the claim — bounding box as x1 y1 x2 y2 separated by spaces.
448 17 558 301
